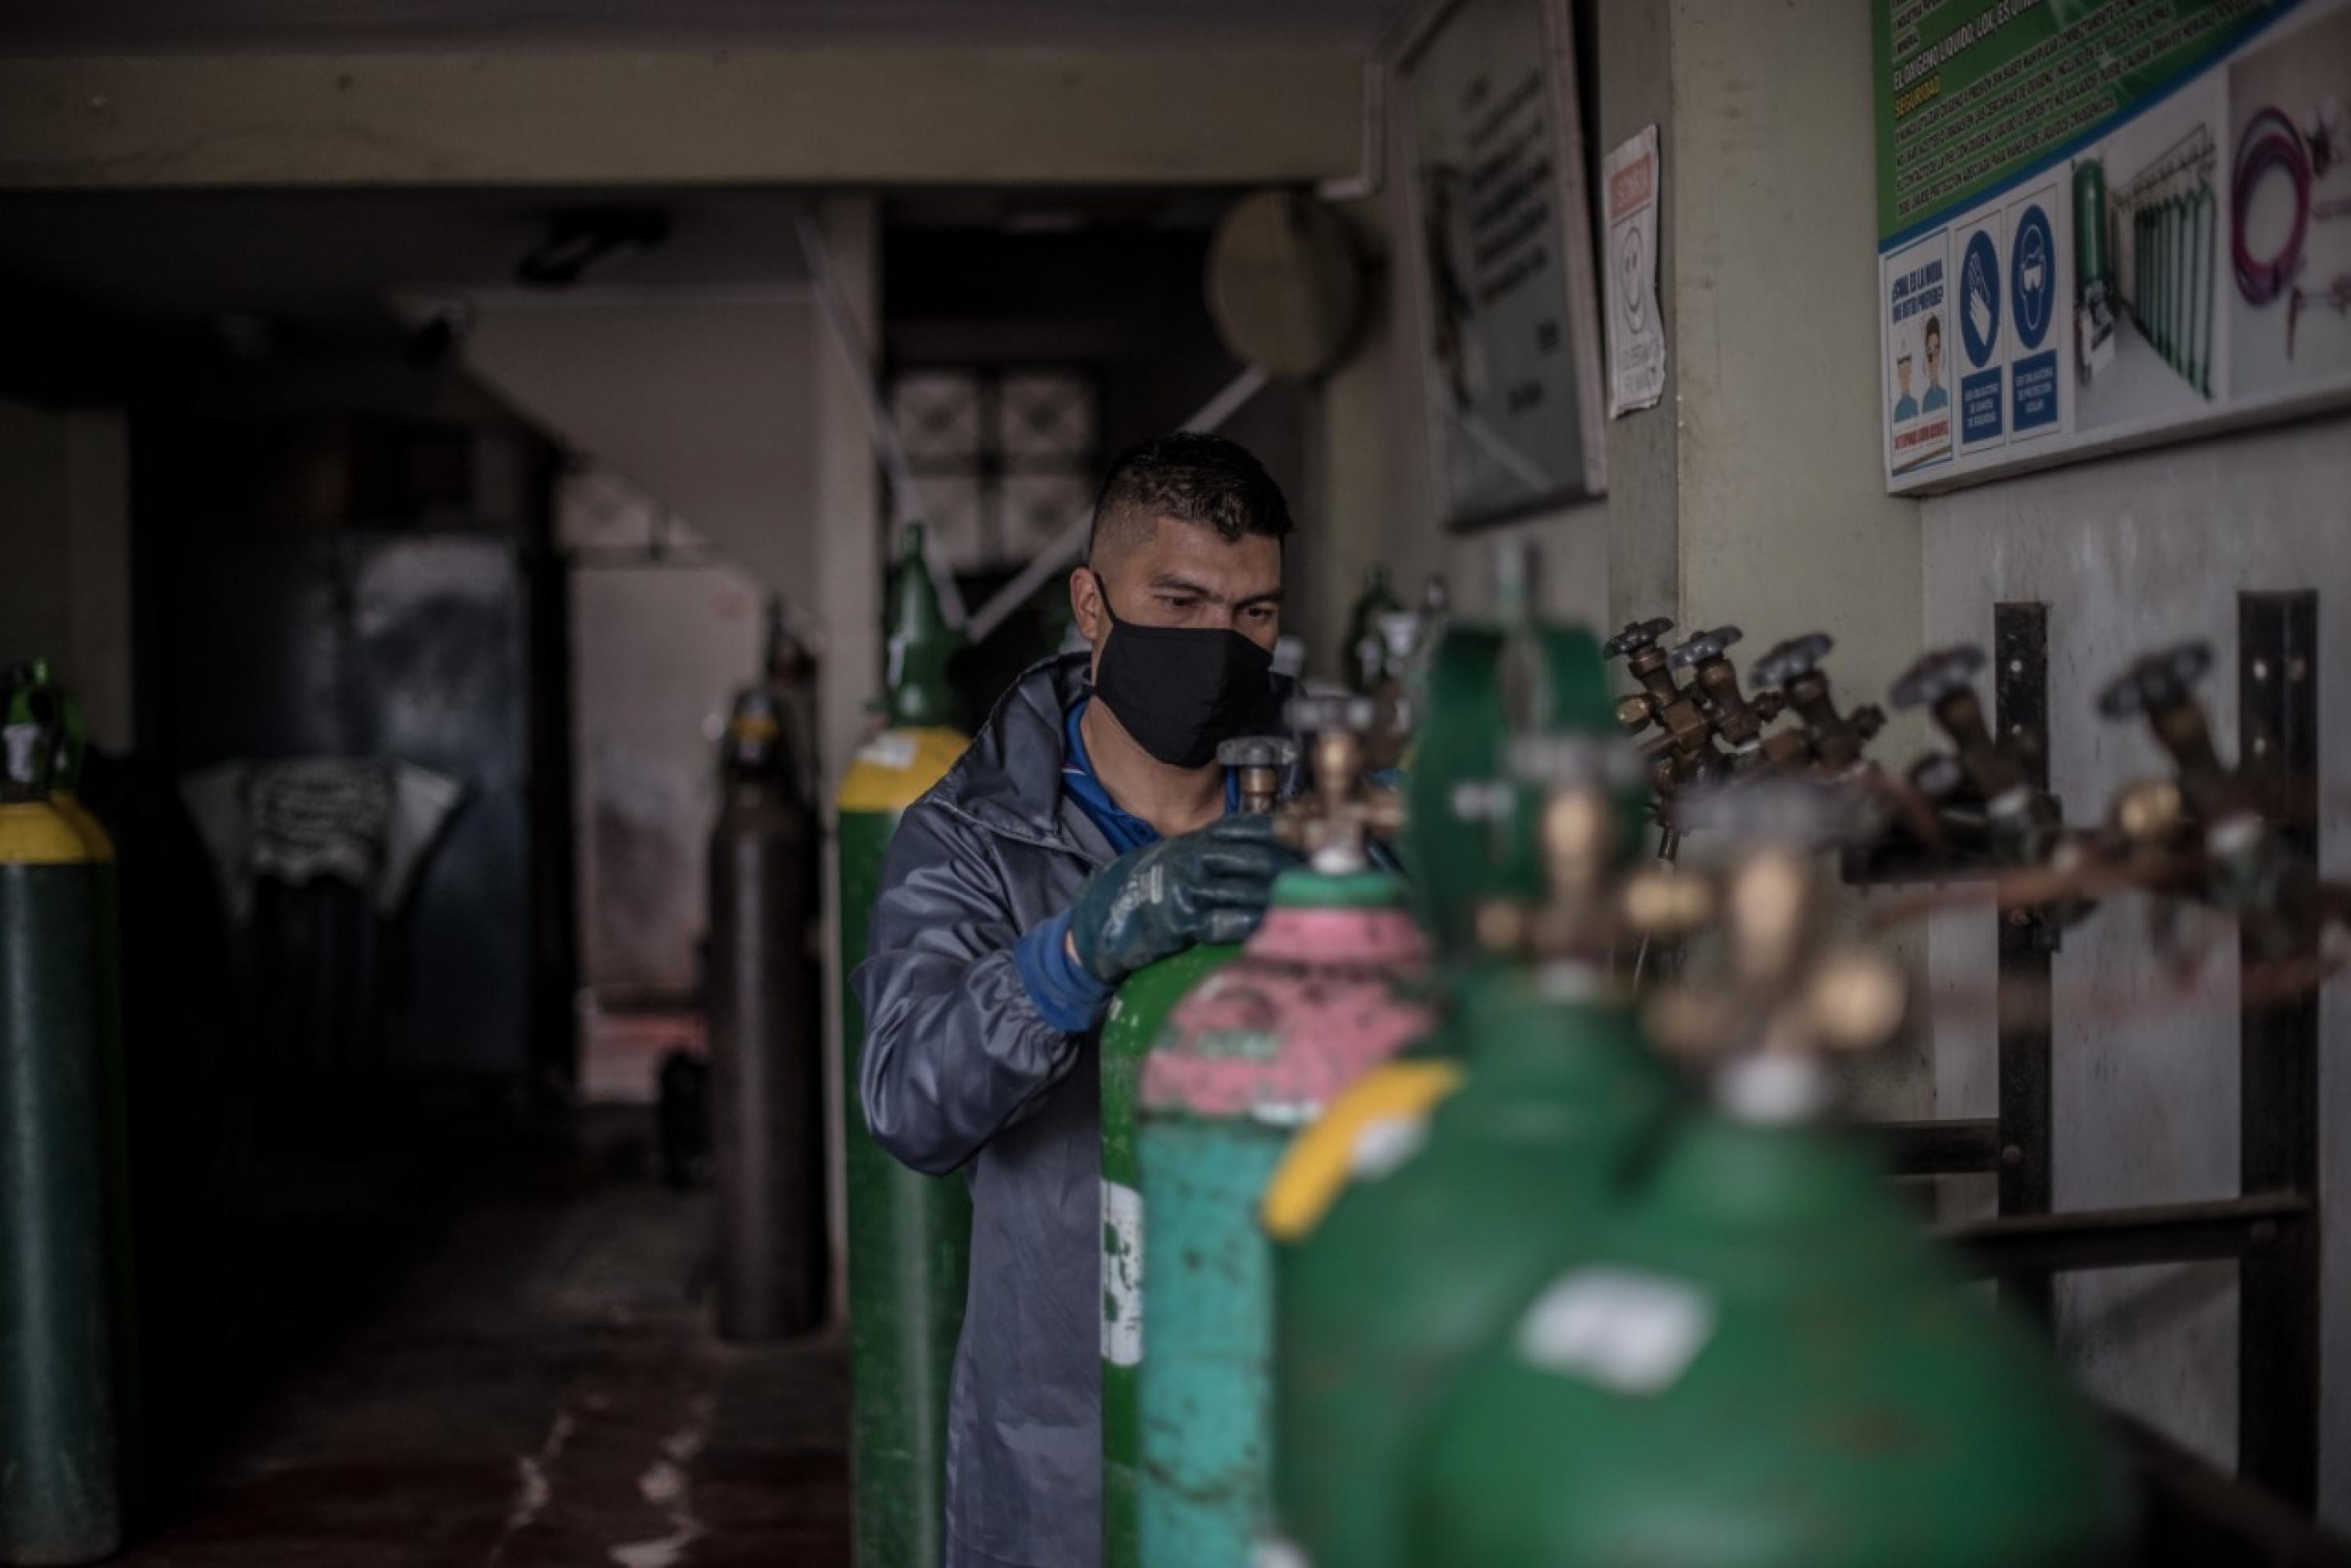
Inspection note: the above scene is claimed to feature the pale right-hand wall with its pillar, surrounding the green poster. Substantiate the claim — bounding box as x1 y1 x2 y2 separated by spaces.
1664 0 2351 1516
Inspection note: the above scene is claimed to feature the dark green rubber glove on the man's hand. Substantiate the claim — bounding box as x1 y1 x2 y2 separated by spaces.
1070 816 1298 985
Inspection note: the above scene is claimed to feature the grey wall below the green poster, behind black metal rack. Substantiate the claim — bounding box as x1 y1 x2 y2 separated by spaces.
1923 416 2351 1528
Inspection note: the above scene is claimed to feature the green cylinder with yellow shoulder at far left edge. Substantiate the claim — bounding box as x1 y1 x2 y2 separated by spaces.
0 689 122 1563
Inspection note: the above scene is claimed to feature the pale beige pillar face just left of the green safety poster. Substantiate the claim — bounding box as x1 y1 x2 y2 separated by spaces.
1667 0 1923 757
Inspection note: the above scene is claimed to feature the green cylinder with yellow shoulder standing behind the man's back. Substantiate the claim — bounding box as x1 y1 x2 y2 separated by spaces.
835 524 971 1568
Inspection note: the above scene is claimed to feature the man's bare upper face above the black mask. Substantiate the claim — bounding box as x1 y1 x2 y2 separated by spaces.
1070 517 1281 670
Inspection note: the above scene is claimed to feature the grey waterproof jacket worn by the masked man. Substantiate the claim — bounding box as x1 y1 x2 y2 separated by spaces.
853 654 1286 1568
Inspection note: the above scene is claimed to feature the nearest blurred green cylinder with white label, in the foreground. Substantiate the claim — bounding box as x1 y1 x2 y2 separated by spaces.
1411 1058 2128 1568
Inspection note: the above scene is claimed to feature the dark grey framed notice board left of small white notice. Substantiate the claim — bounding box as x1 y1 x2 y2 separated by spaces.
1396 0 1606 529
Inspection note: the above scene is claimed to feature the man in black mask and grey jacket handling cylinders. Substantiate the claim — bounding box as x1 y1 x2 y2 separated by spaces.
855 435 1293 1568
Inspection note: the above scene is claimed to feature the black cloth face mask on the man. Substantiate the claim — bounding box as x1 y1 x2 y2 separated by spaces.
1093 574 1274 769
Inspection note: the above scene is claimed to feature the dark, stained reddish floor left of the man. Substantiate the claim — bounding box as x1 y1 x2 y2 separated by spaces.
120 1110 849 1568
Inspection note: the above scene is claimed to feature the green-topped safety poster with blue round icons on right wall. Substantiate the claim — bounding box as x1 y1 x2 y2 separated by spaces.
1872 0 2351 491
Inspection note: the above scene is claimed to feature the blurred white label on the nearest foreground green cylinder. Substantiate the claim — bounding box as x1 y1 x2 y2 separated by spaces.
1519 1267 1714 1394
